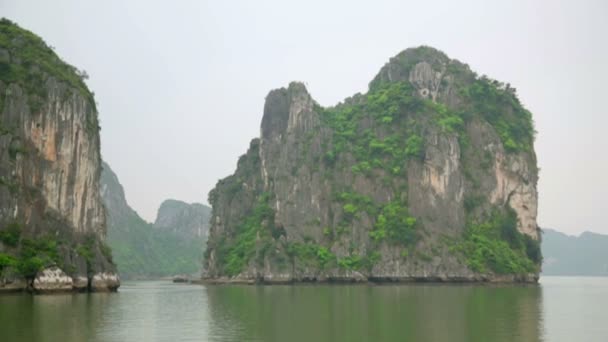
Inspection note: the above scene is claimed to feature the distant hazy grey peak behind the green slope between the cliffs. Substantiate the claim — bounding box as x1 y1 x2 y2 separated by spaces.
154 199 211 241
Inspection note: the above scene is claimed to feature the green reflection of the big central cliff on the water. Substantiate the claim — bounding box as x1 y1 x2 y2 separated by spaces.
207 285 541 342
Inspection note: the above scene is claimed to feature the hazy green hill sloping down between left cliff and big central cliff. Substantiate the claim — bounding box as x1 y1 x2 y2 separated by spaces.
101 163 208 279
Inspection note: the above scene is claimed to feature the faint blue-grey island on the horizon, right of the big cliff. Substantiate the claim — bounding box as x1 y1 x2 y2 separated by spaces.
541 229 608 276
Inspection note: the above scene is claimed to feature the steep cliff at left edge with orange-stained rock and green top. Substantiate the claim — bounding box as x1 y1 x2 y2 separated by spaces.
0 19 119 291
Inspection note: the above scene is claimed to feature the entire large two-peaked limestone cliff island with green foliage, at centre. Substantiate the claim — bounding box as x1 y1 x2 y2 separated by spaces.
204 47 541 282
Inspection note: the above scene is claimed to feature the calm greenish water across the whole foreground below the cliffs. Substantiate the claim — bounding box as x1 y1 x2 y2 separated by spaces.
0 277 608 342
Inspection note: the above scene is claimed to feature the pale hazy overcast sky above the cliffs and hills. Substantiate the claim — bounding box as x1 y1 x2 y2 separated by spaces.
0 0 608 234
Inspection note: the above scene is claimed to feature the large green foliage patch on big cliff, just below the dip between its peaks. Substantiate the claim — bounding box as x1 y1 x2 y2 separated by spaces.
322 82 424 174
